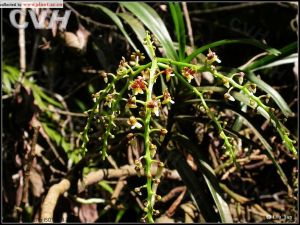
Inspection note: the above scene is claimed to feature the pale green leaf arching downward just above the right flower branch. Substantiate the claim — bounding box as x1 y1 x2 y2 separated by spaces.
246 71 294 117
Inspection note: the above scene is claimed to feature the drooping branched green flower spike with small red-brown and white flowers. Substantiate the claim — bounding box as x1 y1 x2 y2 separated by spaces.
82 32 297 222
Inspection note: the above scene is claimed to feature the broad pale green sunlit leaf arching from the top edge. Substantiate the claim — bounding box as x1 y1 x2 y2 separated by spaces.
120 2 178 60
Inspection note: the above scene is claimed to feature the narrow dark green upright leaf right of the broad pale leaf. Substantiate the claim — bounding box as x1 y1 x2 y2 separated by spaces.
169 2 186 60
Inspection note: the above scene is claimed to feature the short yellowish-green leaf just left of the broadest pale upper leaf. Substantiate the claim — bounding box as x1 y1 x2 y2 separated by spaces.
118 12 151 57
